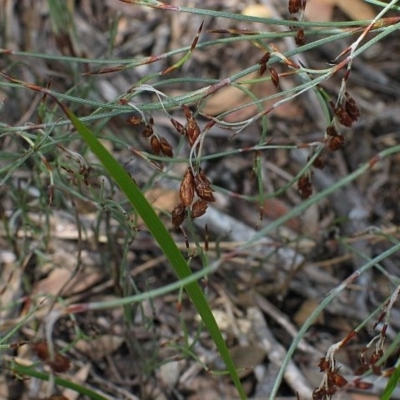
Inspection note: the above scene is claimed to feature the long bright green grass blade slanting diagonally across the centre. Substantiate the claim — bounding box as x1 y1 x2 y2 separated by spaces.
62 105 246 399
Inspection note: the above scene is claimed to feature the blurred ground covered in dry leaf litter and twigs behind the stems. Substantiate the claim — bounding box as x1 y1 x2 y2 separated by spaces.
0 0 400 400
